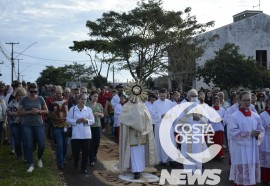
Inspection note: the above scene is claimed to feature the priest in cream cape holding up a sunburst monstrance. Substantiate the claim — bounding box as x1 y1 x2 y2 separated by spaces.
119 84 158 179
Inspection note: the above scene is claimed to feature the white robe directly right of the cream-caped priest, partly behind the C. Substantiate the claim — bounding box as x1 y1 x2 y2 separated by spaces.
154 99 176 163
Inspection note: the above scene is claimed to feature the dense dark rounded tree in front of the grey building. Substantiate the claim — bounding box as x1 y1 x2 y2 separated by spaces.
197 43 270 91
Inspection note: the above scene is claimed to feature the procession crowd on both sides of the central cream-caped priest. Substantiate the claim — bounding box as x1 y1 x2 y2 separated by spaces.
0 81 270 185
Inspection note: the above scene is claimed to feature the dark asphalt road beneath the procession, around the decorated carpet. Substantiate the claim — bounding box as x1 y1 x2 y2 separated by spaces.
63 136 263 186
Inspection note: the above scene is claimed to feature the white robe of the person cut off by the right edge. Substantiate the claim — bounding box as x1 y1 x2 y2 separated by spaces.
260 111 270 169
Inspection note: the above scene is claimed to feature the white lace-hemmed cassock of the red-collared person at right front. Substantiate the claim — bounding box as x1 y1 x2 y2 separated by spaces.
228 110 264 185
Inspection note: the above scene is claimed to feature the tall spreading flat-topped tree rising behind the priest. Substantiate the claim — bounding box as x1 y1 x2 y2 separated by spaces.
70 0 214 80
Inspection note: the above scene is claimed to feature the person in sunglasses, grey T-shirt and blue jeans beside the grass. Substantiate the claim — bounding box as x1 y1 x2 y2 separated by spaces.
18 83 48 172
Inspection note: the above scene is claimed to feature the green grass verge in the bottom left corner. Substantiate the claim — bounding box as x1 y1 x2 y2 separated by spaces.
0 142 64 186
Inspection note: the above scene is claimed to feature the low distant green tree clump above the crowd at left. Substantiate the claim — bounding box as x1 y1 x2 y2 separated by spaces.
36 63 93 86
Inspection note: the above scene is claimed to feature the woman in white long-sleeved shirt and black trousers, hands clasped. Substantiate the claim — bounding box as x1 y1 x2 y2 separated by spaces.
67 94 95 174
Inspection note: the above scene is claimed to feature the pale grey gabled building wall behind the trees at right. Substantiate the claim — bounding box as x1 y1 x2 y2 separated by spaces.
194 10 270 89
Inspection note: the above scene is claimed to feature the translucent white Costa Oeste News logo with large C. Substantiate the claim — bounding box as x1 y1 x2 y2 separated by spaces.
159 102 222 185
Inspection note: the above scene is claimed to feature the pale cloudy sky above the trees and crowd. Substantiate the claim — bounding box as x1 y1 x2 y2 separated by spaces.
0 0 270 84
